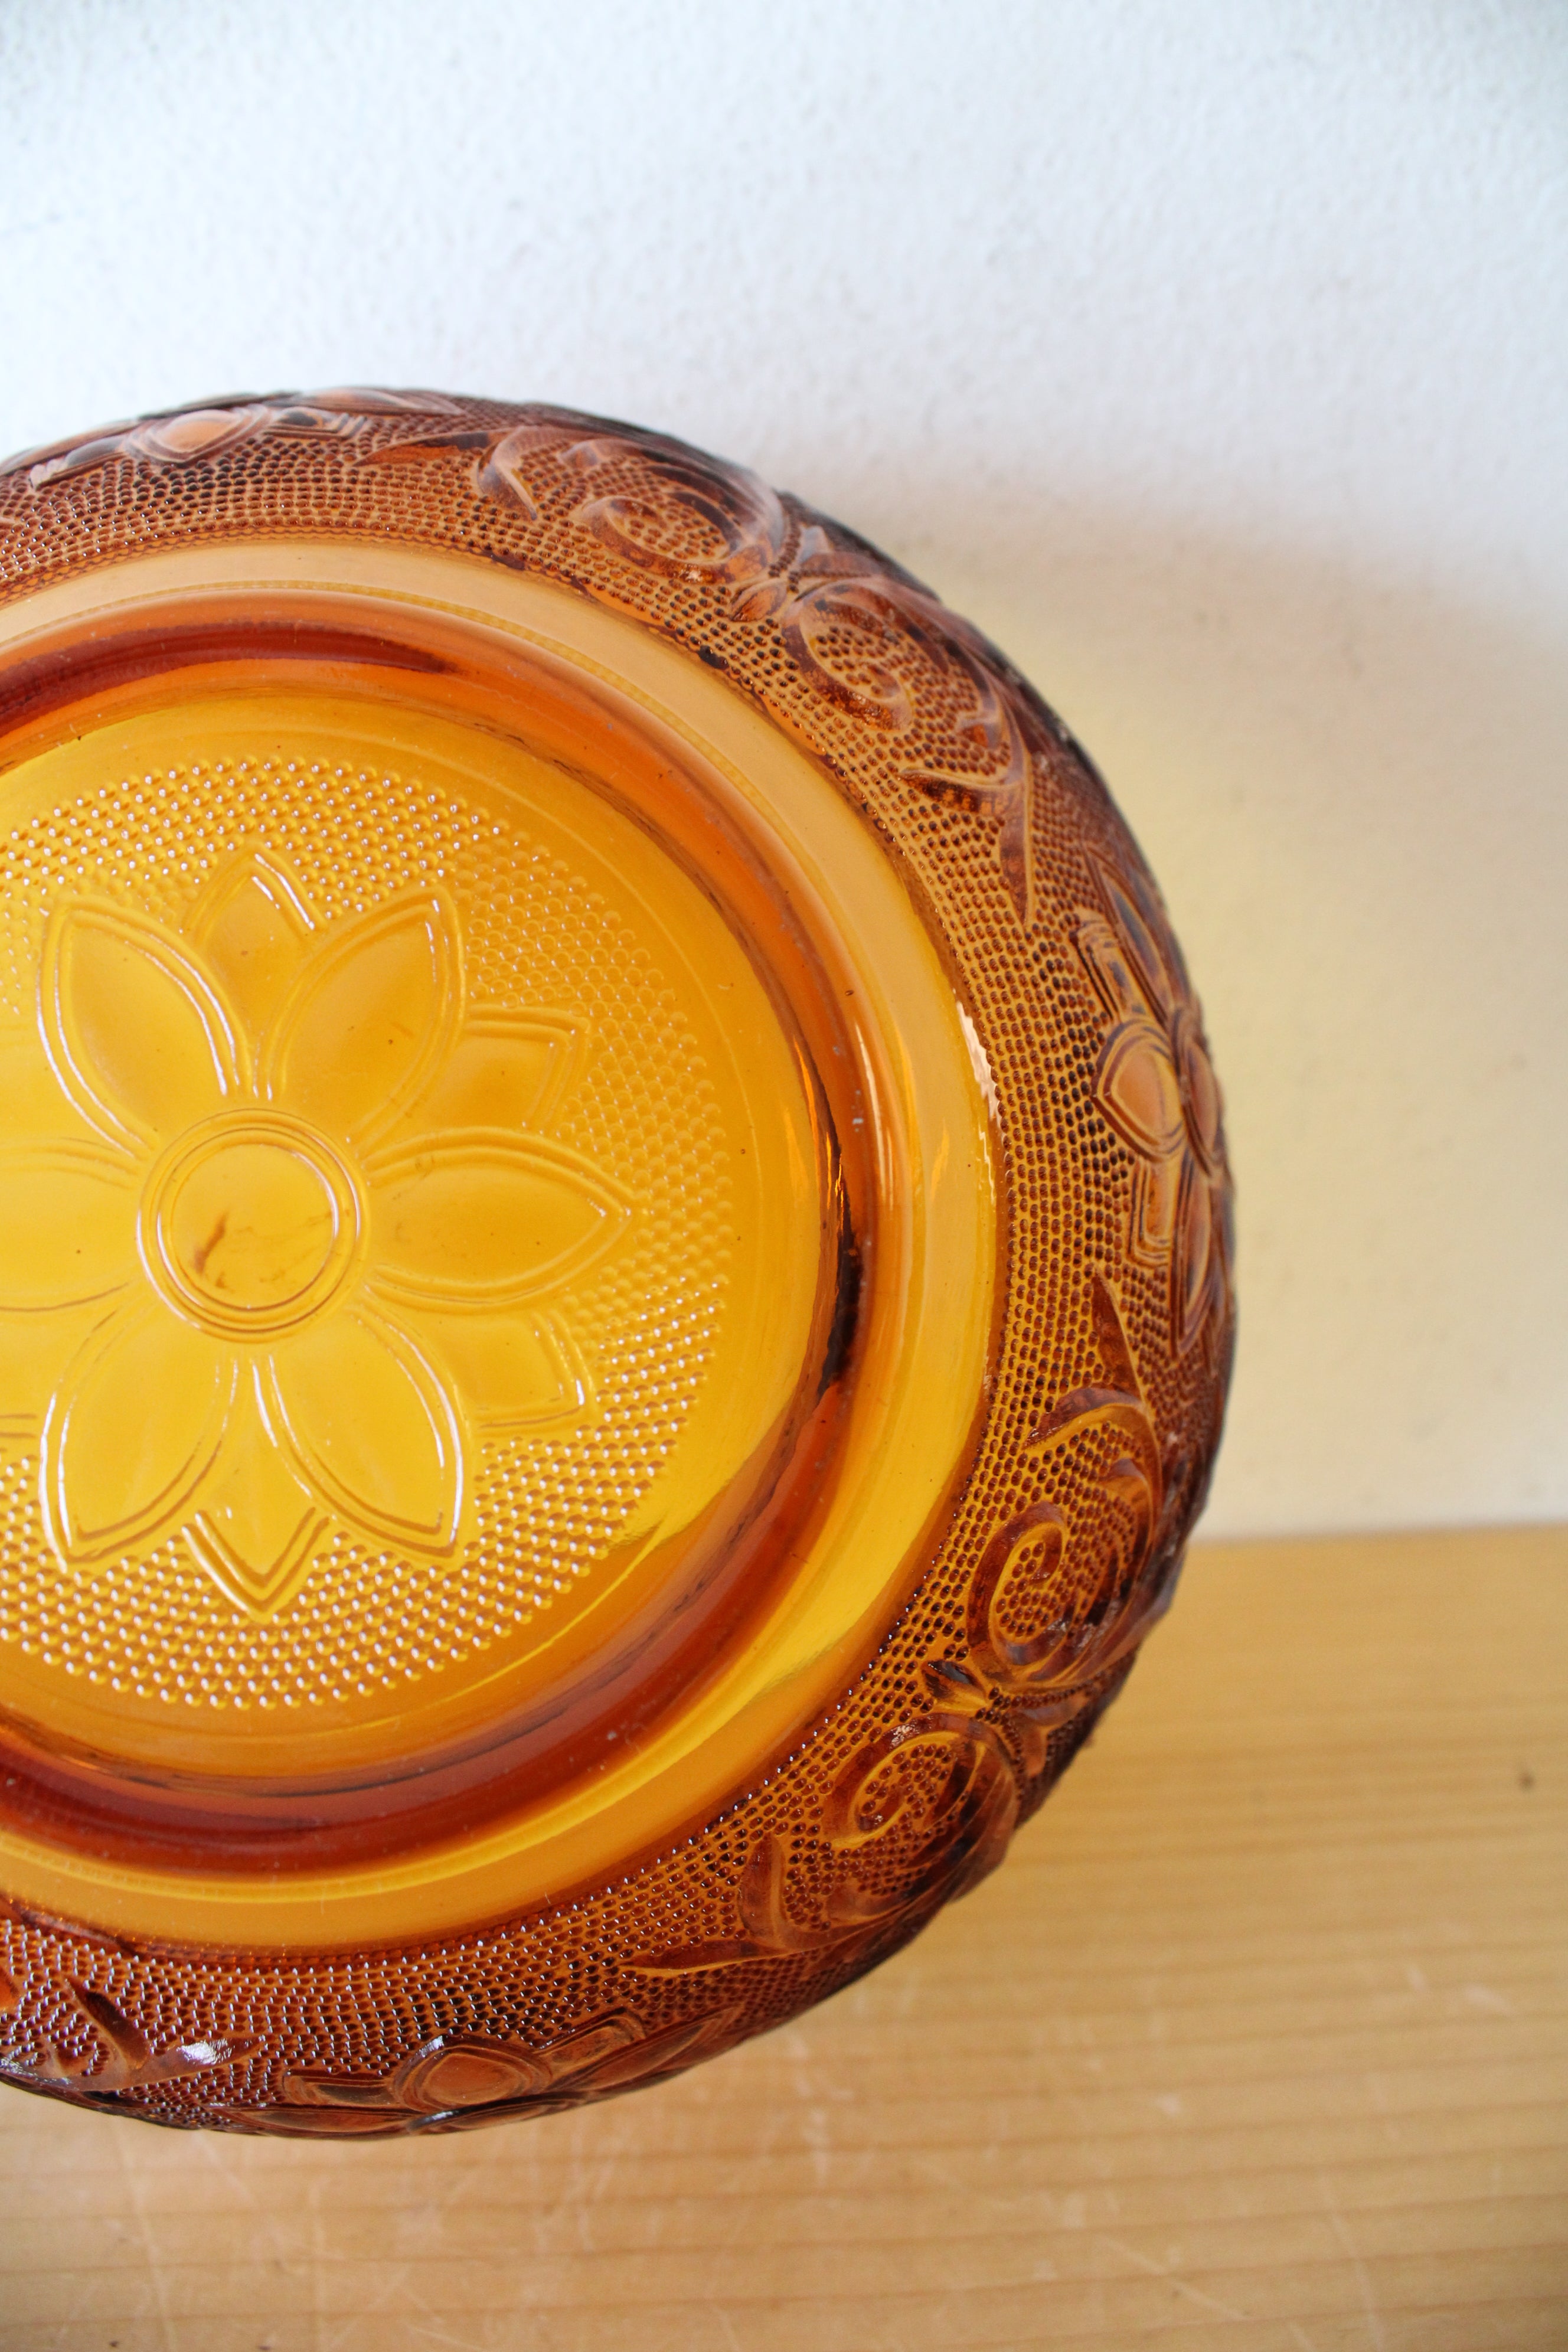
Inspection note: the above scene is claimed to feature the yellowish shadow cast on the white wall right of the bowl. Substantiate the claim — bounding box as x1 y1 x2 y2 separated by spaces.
851 485 1568 1536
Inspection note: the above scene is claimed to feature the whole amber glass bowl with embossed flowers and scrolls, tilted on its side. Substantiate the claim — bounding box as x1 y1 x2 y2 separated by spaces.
0 390 1232 2135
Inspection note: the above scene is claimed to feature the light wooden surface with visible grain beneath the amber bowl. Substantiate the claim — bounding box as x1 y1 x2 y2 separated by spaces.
0 1531 1568 2352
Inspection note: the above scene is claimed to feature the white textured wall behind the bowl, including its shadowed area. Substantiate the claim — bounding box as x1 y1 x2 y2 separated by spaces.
0 0 1568 1534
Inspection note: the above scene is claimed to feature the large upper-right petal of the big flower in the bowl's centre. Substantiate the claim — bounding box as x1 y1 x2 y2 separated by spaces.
263 889 463 1143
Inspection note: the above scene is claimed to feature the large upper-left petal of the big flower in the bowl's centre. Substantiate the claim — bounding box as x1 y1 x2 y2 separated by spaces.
40 899 249 1148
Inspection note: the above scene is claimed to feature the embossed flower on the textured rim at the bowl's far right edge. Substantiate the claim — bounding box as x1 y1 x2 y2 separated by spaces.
1077 865 1232 1350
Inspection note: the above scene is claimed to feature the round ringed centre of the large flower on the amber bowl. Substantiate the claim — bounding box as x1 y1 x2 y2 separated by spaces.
141 1112 362 1338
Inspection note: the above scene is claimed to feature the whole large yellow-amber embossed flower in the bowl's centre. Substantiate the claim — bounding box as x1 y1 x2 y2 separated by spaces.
0 851 630 1613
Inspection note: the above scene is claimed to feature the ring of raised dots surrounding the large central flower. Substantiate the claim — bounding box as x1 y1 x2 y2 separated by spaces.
0 755 729 1712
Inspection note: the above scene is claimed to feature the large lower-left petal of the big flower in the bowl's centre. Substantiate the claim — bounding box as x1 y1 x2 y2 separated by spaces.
40 1303 235 1564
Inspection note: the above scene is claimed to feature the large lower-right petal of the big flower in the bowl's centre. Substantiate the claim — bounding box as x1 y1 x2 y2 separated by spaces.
263 1305 463 1557
